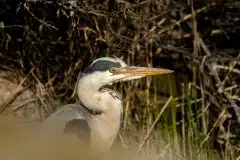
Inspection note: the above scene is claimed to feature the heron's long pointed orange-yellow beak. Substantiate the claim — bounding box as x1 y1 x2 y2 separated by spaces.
115 66 173 77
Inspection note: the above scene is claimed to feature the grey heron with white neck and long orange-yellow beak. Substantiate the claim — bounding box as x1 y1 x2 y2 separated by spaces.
41 57 173 150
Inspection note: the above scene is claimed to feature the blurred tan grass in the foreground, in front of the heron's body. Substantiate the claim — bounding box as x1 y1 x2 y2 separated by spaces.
0 117 219 160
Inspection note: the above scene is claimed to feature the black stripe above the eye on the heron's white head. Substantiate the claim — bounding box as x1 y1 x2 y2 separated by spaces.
84 60 121 73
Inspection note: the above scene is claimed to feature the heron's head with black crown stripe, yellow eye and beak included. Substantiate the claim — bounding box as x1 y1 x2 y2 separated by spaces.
79 57 173 86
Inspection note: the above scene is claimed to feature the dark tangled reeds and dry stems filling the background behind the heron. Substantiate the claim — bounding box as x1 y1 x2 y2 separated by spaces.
0 0 240 160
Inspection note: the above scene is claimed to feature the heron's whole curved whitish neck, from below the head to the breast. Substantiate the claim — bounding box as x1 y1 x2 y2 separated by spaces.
77 77 122 149
